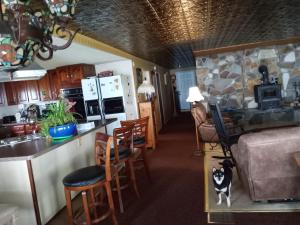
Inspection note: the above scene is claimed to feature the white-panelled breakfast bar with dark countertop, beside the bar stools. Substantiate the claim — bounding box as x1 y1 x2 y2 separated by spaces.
0 119 115 225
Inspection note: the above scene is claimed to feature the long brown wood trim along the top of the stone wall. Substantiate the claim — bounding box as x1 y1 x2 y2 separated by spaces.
193 36 300 57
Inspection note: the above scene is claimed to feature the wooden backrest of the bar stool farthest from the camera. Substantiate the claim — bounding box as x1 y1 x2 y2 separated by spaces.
121 116 149 143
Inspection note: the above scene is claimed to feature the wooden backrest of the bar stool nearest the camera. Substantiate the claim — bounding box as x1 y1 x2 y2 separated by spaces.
94 132 113 181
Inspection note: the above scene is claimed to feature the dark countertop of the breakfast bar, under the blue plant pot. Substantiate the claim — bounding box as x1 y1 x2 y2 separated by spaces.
0 119 116 162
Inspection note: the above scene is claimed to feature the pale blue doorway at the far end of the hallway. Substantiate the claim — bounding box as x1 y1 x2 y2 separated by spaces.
175 70 197 111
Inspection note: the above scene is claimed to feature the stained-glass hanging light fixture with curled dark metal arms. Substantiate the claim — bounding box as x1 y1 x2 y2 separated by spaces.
0 0 79 70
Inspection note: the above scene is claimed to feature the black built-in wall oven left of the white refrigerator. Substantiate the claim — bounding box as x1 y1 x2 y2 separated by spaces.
60 88 86 120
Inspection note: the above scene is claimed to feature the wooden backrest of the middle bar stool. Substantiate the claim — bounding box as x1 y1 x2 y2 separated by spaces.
113 124 134 163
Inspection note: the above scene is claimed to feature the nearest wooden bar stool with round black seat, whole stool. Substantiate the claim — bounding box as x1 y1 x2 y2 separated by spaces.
63 133 118 225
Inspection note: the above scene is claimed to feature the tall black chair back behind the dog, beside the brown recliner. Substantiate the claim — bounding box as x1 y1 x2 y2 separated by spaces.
209 104 229 146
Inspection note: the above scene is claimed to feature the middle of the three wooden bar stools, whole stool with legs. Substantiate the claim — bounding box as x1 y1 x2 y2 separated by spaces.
110 124 140 213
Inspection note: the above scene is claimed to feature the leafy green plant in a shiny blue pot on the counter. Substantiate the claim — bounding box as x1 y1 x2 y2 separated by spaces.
41 99 77 140
